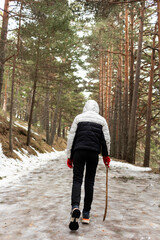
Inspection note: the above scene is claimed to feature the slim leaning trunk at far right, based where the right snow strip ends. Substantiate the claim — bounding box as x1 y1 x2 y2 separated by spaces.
144 25 157 167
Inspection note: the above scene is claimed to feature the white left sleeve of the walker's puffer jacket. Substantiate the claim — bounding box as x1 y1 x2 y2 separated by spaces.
67 118 77 158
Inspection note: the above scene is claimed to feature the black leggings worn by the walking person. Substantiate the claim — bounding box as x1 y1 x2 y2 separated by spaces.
72 150 98 211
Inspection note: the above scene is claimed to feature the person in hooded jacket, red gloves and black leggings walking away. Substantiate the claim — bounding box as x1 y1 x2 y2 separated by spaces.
67 100 110 230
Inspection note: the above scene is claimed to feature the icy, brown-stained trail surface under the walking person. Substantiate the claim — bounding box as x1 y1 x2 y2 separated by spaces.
0 152 160 240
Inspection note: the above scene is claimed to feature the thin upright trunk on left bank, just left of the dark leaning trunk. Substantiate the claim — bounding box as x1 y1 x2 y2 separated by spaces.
9 55 16 152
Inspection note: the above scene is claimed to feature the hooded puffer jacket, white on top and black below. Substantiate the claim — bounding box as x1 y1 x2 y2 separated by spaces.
67 100 110 159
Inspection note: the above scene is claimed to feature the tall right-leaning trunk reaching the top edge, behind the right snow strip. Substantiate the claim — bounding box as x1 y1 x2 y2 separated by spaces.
127 2 145 163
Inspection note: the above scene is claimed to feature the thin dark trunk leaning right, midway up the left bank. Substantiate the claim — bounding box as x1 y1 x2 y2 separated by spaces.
27 43 39 146
